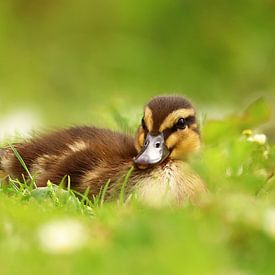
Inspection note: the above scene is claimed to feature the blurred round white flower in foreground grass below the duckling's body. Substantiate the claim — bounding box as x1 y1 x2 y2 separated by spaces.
38 219 88 254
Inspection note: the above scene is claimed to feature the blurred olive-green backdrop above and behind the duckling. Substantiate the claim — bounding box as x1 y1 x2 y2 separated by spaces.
0 0 275 132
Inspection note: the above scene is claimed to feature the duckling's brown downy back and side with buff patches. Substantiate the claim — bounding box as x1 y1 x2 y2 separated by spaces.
1 127 137 194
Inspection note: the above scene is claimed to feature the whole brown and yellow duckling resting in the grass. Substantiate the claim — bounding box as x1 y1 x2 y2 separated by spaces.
0 96 206 206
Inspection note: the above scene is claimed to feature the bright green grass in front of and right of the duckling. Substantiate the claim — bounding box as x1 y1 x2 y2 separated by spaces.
0 100 275 275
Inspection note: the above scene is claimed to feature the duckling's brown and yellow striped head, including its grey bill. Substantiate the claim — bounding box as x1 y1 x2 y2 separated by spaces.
134 96 200 168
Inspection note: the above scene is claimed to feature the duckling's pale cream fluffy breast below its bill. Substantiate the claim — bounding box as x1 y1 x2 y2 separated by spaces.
133 160 206 206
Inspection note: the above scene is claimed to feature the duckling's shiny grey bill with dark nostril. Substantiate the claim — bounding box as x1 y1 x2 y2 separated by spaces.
134 133 170 168
